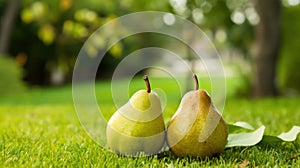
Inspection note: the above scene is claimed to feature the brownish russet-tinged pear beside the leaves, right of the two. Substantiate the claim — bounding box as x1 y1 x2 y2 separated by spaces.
167 75 228 158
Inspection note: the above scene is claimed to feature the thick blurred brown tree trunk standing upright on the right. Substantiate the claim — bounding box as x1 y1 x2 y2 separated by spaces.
253 0 281 97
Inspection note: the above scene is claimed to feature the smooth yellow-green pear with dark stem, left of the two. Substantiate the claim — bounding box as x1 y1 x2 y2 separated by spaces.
106 76 165 156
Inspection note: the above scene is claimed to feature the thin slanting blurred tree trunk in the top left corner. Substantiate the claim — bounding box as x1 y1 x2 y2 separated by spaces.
0 0 20 56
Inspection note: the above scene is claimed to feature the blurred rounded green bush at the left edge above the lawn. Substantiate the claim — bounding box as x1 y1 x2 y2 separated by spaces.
0 55 26 96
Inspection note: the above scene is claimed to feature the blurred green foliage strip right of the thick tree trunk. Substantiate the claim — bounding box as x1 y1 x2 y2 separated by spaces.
278 5 300 95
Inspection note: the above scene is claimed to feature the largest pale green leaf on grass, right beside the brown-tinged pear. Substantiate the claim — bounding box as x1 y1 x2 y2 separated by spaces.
226 126 265 148
